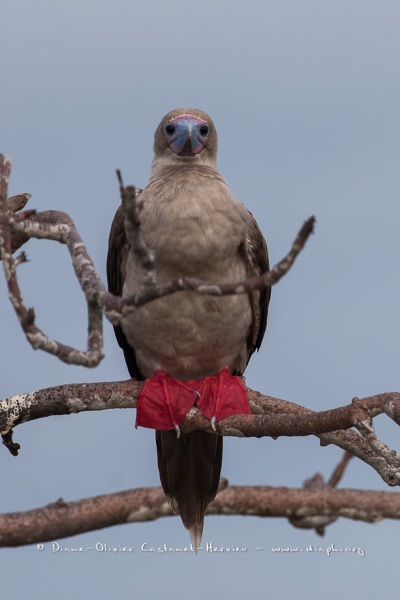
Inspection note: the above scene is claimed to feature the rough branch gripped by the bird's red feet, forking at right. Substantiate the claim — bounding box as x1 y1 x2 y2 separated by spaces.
0 380 400 486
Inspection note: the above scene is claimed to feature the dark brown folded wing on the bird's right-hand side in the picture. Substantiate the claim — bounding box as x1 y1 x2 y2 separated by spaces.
242 212 271 362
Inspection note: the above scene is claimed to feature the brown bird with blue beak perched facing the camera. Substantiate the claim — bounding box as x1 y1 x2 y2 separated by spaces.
107 108 270 549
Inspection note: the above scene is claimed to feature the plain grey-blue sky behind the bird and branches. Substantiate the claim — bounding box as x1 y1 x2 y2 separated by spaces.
0 0 400 600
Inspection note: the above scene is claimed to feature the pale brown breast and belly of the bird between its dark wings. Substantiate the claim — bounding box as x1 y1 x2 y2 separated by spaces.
122 168 251 379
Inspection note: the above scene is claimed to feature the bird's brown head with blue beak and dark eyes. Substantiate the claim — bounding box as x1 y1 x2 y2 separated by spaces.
154 108 217 164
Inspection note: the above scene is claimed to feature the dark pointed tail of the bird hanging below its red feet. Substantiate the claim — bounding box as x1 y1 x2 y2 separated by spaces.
156 431 223 552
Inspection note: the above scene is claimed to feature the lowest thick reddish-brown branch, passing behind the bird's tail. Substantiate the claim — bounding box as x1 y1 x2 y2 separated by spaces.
0 486 400 547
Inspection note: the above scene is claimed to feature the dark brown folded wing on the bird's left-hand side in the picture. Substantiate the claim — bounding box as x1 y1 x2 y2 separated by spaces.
107 204 144 379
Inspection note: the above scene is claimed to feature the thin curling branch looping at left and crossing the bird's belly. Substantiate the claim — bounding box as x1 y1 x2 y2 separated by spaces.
0 155 315 367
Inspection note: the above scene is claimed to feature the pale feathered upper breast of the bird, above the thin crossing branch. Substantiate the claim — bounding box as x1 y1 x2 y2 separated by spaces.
141 171 245 277
